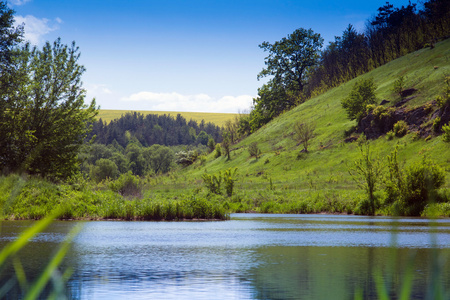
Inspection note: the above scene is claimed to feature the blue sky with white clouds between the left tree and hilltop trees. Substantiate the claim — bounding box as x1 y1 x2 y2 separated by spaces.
9 0 408 113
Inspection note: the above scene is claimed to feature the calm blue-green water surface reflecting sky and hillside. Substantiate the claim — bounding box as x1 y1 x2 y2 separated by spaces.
0 214 450 299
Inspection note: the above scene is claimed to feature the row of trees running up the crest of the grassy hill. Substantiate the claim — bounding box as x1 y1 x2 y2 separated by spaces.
248 0 450 134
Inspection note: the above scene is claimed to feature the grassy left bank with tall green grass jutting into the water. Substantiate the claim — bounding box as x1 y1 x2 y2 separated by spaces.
0 175 229 221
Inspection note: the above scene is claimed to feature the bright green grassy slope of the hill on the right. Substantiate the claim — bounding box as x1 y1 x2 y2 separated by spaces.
152 40 450 216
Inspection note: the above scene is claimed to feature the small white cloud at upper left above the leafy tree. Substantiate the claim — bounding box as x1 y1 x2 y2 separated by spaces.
14 15 62 45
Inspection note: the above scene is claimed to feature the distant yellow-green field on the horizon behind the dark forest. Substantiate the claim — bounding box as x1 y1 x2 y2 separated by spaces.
98 109 238 126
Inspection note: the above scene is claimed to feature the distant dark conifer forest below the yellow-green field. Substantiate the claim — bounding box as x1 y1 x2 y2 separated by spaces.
87 112 221 148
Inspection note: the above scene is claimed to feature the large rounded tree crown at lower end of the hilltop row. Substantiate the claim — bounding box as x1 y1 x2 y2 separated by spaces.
258 28 323 92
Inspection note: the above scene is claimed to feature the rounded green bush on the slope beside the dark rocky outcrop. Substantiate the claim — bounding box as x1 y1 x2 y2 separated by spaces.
341 78 377 122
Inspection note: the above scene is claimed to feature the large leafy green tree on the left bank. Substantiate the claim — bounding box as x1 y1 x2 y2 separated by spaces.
0 39 98 178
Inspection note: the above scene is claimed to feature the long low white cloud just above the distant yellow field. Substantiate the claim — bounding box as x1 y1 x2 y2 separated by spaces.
122 92 253 113
